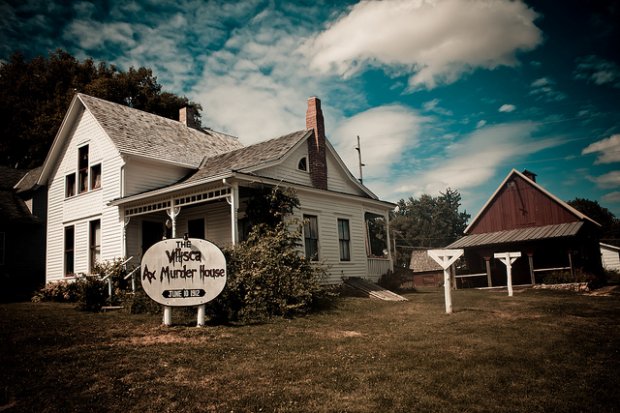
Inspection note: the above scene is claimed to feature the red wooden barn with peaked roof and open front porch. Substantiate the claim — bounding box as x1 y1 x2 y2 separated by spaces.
447 169 602 286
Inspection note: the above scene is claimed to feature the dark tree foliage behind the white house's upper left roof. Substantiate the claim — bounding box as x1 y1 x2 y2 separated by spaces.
0 49 202 168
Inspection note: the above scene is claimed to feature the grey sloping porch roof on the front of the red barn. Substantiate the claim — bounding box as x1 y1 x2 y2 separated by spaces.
446 221 584 248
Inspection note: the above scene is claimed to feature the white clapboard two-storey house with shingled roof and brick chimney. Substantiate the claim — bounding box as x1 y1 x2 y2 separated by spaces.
38 94 394 283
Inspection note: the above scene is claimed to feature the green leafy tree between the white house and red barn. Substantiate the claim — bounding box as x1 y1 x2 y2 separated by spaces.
390 188 470 265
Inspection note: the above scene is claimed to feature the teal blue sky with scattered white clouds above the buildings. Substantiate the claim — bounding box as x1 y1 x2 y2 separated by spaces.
0 0 620 217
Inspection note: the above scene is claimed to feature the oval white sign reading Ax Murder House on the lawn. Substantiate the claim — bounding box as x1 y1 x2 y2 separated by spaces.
140 238 226 307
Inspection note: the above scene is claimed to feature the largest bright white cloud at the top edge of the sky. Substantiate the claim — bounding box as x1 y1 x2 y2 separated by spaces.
304 0 542 89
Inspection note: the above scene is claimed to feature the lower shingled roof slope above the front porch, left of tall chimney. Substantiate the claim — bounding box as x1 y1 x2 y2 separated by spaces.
185 130 312 182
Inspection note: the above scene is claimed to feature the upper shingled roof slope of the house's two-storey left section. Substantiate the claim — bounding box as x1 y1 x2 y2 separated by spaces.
77 93 243 168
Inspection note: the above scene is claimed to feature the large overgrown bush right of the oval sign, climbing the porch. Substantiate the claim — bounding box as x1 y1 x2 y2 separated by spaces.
209 222 329 323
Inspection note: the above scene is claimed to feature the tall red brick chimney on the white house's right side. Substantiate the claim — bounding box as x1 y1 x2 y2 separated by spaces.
306 97 327 189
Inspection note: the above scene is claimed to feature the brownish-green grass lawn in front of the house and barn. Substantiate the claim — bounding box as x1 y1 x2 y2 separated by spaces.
0 289 620 413
